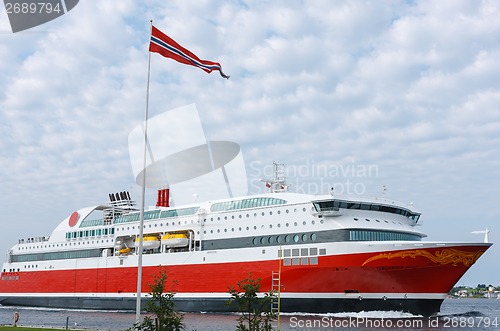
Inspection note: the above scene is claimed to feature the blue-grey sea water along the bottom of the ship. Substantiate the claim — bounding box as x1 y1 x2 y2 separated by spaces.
0 299 500 331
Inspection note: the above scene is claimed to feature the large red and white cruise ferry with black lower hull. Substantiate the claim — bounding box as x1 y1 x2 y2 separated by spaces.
0 170 491 316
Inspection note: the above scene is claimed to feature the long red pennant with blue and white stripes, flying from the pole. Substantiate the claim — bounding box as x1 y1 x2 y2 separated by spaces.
149 26 229 79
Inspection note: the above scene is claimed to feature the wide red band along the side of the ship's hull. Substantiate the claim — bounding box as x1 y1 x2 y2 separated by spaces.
0 245 489 295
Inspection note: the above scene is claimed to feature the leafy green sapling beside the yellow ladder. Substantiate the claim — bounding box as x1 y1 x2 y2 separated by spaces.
227 273 276 331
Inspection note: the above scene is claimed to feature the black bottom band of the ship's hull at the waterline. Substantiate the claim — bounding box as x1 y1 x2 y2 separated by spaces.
0 297 443 316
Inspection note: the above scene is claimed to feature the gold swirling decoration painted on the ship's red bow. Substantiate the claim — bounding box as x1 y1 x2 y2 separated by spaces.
362 248 484 267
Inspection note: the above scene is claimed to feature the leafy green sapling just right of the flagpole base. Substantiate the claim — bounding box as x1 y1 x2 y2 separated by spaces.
134 270 184 331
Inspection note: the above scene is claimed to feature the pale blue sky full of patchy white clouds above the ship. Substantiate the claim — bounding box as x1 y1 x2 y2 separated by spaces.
0 0 500 286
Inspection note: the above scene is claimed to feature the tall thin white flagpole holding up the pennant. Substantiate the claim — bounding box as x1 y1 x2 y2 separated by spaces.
135 20 153 323
